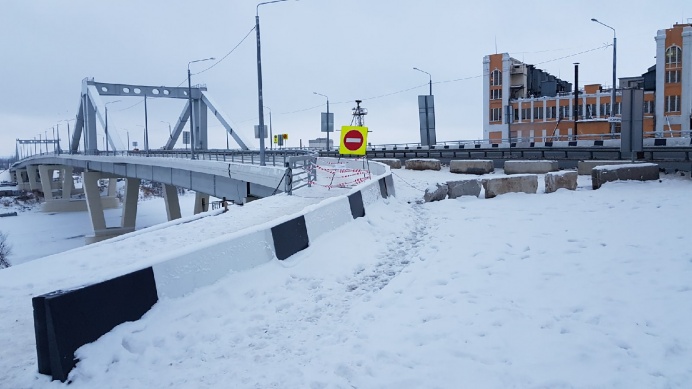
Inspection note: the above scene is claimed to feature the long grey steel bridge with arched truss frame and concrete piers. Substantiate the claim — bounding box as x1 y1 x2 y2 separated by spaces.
10 78 317 243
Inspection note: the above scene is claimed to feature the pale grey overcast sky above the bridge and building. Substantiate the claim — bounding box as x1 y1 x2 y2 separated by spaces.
0 0 692 155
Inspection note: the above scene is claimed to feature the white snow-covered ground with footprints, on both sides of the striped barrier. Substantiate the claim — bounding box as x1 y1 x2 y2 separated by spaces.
0 169 692 389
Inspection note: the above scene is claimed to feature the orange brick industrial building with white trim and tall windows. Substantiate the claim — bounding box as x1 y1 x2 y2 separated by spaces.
483 24 692 143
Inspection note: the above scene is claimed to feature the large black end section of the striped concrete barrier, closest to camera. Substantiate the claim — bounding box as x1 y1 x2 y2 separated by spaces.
32 267 158 382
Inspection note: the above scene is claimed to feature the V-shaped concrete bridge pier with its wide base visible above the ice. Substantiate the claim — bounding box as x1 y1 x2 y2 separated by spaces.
82 172 127 244
